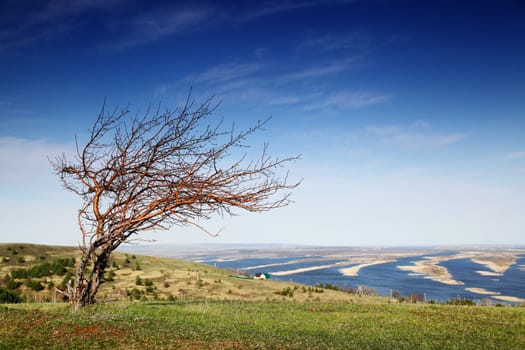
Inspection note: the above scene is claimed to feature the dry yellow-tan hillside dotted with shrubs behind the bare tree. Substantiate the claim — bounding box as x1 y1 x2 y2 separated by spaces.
0 244 376 303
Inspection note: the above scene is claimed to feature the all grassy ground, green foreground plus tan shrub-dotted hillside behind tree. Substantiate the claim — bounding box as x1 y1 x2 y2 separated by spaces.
0 244 525 349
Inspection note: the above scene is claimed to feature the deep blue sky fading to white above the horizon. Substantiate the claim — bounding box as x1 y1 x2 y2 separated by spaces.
0 0 525 245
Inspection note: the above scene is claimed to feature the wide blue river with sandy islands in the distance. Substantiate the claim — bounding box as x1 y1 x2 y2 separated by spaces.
201 251 525 302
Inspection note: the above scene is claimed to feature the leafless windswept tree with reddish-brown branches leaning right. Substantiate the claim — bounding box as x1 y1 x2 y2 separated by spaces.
51 95 299 308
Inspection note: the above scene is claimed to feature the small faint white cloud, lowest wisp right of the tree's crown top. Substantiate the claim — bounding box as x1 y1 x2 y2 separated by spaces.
366 122 468 148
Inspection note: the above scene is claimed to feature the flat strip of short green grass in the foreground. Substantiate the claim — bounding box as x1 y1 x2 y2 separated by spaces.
0 301 525 349
